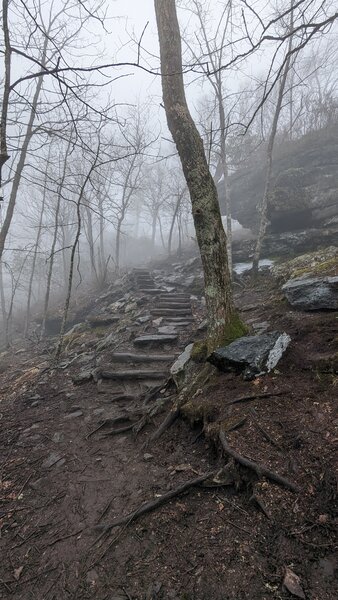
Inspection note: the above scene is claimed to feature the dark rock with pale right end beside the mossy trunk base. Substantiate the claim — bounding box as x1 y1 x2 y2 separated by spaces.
208 331 291 379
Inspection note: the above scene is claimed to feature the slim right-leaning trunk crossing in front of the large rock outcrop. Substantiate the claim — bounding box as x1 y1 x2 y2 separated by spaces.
252 0 294 277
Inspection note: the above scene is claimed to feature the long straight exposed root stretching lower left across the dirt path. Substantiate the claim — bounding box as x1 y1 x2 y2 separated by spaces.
96 470 219 533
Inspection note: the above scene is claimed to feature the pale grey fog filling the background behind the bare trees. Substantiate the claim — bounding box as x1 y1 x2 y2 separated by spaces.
0 0 338 345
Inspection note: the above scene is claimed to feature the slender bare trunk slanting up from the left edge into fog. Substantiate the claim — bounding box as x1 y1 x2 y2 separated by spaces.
0 35 49 259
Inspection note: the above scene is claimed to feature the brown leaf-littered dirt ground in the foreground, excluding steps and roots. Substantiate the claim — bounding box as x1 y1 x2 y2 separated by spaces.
0 279 338 600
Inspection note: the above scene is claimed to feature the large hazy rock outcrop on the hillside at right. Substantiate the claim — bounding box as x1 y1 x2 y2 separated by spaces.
220 124 338 233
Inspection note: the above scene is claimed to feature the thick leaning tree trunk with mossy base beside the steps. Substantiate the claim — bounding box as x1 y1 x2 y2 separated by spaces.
155 0 245 350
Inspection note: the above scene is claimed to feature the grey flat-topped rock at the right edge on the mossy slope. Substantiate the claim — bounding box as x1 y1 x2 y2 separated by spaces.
282 277 338 310
